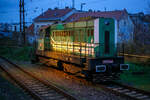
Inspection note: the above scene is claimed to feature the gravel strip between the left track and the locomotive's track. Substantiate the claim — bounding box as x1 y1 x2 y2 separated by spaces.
17 62 129 100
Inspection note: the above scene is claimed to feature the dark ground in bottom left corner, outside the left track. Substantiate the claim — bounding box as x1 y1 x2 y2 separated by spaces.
0 69 33 100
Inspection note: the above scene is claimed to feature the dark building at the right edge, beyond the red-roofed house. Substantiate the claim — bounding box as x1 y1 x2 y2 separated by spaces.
130 12 150 44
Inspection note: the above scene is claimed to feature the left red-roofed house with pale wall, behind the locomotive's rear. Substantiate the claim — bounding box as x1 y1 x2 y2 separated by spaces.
34 7 77 33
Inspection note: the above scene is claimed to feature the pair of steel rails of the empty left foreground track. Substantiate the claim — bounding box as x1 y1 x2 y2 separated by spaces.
0 57 79 100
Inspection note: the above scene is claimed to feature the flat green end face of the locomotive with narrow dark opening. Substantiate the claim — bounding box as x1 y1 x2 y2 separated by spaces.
99 18 115 57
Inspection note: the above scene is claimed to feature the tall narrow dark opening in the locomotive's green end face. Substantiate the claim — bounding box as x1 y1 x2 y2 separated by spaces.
105 31 110 54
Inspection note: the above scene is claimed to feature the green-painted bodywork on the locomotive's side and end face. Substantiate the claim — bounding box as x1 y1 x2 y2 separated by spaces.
44 18 116 57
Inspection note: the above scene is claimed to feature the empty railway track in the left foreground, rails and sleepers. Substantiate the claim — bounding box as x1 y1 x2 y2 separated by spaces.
0 58 77 100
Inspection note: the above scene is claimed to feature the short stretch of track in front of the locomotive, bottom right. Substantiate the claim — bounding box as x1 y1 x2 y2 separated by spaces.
97 82 150 100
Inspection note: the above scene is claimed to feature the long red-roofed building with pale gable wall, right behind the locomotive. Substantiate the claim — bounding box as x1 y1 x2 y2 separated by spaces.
66 9 134 42
